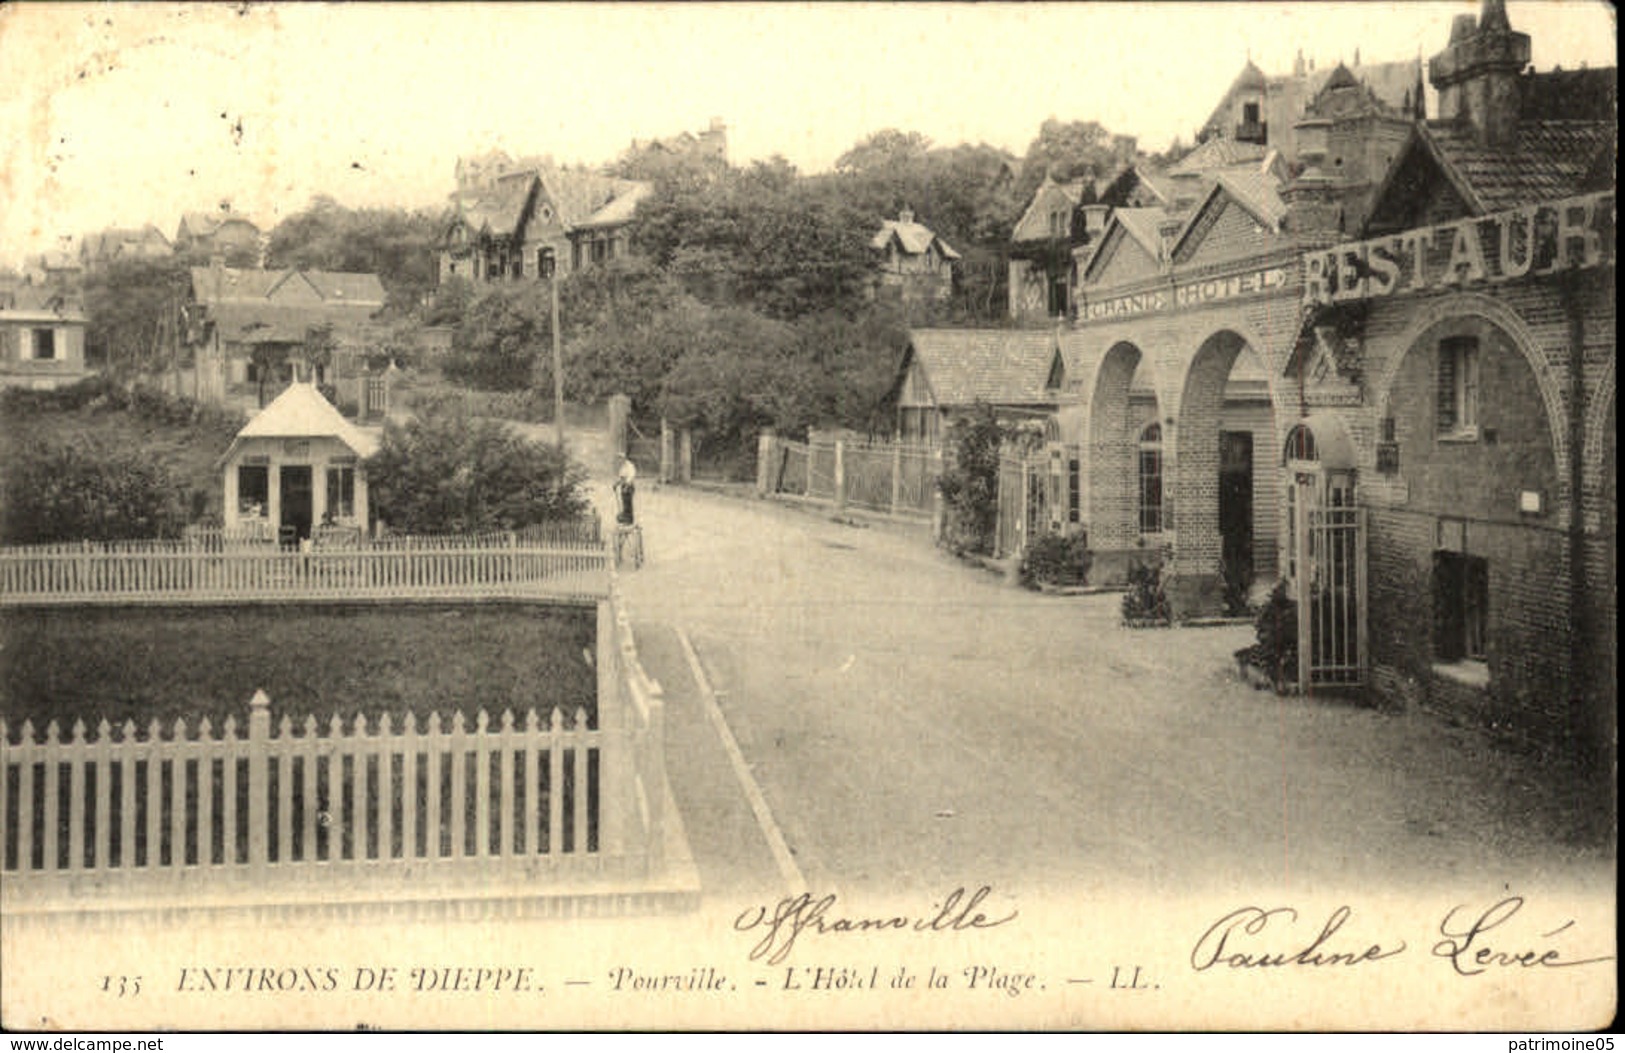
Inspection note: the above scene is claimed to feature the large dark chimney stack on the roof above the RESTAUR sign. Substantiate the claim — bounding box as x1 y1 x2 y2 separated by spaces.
1427 0 1529 146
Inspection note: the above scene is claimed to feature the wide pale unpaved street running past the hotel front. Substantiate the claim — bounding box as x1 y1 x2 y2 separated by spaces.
621 486 1612 894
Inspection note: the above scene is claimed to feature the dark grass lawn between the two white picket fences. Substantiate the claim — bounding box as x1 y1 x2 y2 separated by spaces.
0 603 596 738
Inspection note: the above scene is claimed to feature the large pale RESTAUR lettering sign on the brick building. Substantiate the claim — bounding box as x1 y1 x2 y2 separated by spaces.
1303 190 1615 304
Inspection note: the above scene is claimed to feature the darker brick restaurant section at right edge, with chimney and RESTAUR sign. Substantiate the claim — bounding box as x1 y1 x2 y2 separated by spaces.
1294 0 1617 756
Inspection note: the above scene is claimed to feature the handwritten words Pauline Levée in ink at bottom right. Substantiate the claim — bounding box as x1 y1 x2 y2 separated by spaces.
1191 895 1614 977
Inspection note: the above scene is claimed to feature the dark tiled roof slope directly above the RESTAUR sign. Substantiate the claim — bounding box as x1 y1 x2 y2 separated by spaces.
1419 120 1617 213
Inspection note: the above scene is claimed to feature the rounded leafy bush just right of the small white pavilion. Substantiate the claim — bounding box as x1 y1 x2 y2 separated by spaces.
367 398 587 533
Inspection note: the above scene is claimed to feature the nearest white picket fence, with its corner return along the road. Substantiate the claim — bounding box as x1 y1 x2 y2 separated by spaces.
0 601 668 907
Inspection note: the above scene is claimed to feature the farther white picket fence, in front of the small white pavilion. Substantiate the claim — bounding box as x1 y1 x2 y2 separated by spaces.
0 535 611 605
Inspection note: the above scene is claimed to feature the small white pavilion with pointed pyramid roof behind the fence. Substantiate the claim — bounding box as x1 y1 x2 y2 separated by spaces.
219 384 379 544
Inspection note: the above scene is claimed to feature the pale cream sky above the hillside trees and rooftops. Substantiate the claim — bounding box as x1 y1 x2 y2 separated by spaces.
0 0 1615 265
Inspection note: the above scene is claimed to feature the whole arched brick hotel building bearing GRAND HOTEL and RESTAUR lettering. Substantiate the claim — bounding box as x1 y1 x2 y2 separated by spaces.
1027 0 1617 765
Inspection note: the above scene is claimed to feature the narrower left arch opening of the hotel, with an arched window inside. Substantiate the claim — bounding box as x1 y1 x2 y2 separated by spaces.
1089 341 1167 580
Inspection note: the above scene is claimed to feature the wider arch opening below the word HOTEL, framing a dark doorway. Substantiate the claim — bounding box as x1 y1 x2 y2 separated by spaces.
1170 328 1281 613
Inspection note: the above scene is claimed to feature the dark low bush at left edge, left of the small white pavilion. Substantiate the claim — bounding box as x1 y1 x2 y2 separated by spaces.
0 442 185 544
